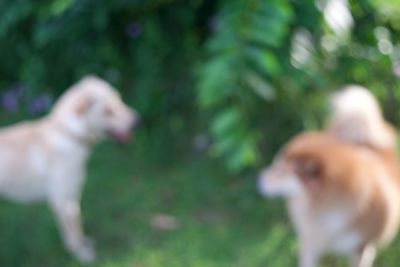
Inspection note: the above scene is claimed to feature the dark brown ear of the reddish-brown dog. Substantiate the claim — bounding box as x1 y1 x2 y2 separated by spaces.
297 158 323 192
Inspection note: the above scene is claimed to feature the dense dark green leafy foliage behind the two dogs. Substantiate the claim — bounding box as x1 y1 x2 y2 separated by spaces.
0 0 400 171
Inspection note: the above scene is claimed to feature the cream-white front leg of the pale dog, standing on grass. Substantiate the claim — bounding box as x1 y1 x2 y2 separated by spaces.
51 200 96 263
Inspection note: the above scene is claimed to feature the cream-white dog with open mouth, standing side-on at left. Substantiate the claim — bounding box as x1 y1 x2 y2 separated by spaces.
0 76 138 262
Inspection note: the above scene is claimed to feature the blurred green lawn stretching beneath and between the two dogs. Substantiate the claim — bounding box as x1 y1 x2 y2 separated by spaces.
0 141 400 267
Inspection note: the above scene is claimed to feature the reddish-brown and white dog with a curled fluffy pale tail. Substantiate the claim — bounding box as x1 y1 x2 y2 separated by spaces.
259 86 400 267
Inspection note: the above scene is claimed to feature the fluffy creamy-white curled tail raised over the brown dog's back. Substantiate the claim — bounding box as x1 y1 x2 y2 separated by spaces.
328 85 396 149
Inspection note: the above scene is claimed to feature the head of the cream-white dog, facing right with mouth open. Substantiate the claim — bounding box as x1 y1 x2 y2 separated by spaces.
50 75 139 146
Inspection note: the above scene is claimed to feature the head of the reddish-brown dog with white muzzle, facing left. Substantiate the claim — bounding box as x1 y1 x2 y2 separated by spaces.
258 133 331 197
